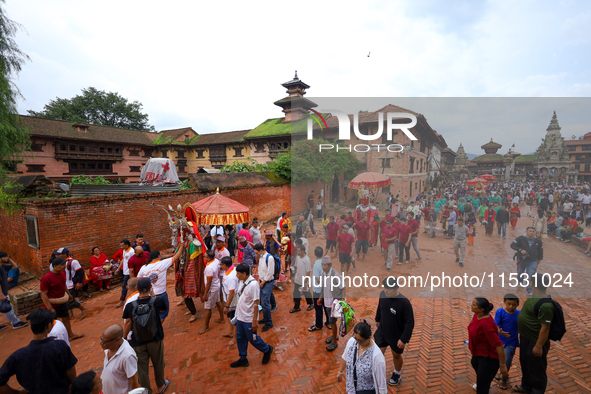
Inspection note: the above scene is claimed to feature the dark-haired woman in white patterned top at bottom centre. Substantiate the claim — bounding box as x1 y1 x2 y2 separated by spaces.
337 320 388 394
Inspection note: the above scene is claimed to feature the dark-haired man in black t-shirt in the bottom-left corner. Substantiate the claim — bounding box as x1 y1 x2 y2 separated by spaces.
0 309 78 394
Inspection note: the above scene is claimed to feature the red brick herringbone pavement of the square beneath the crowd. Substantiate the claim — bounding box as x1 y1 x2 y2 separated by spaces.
0 219 591 394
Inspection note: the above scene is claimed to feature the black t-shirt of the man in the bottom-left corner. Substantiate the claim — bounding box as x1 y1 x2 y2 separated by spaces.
0 337 78 394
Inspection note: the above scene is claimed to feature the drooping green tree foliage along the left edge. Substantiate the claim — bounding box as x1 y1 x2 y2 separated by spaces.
0 0 30 179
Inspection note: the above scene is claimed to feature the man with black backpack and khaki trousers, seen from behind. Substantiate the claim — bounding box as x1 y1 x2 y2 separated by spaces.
123 278 170 394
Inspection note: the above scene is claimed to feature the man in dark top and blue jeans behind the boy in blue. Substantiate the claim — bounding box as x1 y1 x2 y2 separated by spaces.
511 227 544 295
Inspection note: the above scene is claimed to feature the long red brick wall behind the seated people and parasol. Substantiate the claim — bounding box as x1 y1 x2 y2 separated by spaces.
0 185 294 275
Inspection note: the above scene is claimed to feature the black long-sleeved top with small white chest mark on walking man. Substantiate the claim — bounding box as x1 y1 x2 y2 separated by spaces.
374 291 415 354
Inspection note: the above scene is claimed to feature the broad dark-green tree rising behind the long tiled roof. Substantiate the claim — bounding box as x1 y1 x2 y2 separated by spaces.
27 87 156 131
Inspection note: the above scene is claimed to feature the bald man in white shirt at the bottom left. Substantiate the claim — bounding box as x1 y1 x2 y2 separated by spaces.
100 324 140 394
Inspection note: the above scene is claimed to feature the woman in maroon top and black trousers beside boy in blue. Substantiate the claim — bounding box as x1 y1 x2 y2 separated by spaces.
468 297 509 394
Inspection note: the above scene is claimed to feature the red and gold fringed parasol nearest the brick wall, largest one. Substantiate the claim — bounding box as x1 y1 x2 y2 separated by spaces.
184 189 250 225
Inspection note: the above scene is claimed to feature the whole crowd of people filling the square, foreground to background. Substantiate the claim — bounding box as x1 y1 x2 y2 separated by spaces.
0 181 591 394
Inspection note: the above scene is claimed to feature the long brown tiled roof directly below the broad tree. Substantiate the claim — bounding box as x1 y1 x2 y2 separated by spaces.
20 115 157 145
